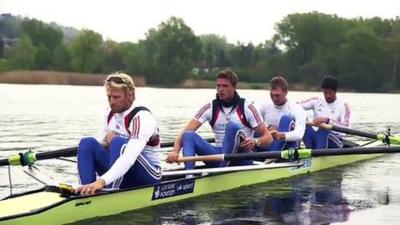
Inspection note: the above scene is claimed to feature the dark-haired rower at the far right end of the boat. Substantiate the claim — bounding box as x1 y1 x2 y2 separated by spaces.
300 76 350 149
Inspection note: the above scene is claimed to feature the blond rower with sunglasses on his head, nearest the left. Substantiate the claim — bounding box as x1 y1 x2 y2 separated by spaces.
76 73 161 194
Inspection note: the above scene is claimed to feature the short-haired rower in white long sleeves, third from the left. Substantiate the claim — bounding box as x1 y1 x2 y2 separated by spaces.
260 76 306 151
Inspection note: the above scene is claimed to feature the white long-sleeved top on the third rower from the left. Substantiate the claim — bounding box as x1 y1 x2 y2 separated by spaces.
260 100 307 141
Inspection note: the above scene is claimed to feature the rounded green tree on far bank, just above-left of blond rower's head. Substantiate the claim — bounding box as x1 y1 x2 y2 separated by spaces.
71 30 103 73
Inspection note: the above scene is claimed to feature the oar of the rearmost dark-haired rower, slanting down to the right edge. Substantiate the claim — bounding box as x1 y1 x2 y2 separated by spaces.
307 123 400 144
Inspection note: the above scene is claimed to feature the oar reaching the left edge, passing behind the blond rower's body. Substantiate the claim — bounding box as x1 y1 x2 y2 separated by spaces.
0 138 214 166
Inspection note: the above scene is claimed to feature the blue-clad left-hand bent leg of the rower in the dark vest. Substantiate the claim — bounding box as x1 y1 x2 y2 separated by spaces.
182 131 221 169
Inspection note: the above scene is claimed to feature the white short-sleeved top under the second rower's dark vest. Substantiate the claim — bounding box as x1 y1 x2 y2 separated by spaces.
194 101 262 147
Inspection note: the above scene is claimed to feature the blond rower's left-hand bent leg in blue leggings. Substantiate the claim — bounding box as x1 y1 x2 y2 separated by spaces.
77 137 109 184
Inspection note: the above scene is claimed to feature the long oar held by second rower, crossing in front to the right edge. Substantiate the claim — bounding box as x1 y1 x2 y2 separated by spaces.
178 146 400 162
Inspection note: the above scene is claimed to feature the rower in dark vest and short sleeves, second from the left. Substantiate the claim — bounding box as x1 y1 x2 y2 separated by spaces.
167 70 272 169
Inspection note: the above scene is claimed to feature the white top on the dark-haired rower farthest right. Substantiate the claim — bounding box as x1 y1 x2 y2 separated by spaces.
300 97 350 127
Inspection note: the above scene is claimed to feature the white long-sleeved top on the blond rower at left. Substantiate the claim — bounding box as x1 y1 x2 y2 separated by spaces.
97 102 161 185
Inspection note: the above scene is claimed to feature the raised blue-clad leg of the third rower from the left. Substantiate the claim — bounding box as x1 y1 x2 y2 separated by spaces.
268 115 298 151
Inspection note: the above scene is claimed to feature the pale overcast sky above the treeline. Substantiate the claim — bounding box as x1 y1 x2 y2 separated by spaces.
0 0 400 44
